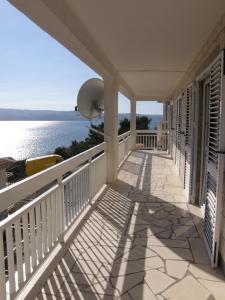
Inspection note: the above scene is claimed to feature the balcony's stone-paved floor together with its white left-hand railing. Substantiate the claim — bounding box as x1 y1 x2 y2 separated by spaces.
0 132 225 299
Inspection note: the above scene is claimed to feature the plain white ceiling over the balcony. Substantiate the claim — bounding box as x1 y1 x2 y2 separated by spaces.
11 0 225 99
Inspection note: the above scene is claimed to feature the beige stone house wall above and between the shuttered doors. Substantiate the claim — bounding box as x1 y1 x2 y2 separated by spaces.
171 15 225 273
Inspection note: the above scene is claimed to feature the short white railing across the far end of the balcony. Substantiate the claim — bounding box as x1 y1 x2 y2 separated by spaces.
136 130 168 151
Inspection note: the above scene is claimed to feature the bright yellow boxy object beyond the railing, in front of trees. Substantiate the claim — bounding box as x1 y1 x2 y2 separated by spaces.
26 154 63 176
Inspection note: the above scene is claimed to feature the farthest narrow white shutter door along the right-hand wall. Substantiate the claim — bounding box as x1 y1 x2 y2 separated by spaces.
176 98 181 174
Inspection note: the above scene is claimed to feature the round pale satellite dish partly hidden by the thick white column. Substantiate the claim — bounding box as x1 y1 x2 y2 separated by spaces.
75 78 104 120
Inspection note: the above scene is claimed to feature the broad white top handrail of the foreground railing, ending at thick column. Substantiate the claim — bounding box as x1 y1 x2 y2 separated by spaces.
0 142 106 212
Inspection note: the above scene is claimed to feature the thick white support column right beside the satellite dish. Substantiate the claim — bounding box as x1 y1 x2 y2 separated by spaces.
104 77 118 183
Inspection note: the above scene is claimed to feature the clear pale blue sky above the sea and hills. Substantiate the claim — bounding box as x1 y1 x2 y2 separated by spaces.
0 0 162 114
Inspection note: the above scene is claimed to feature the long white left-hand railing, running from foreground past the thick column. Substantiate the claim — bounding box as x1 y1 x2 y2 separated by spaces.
0 132 134 299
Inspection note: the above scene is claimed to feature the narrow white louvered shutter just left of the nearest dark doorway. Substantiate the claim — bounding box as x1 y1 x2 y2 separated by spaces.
184 85 193 199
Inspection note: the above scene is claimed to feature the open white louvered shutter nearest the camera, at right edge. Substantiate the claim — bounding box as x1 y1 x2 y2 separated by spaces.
203 55 225 266
